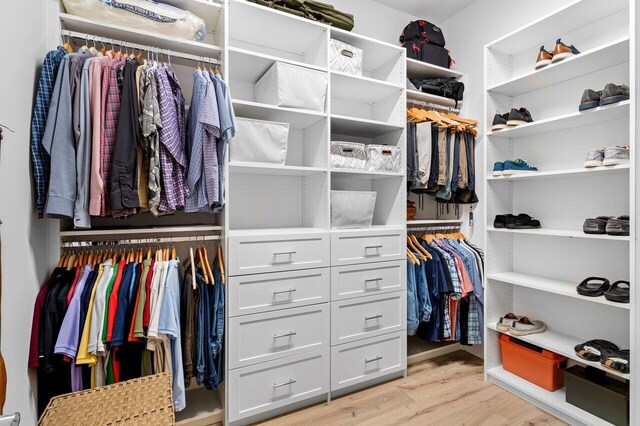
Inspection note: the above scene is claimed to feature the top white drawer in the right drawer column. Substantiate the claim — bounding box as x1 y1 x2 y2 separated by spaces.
331 228 407 266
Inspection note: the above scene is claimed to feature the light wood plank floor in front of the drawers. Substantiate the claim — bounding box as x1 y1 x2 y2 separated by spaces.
255 351 565 426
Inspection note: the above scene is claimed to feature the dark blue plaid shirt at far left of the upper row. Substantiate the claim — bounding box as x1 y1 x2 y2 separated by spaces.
31 47 67 218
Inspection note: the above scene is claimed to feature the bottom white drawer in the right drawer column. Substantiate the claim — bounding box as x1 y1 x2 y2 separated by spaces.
331 331 407 391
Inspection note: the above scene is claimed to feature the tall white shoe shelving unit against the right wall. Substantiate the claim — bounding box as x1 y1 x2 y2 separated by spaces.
483 0 637 425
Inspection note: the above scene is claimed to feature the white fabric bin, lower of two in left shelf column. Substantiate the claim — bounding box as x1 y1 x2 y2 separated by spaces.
229 117 289 166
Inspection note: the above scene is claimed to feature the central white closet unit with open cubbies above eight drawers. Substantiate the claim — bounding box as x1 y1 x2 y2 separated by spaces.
225 0 406 424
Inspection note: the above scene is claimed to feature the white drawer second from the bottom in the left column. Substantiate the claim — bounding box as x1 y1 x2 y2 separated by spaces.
229 303 330 368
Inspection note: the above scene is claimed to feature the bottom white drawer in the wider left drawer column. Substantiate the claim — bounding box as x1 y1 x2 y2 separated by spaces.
227 348 331 422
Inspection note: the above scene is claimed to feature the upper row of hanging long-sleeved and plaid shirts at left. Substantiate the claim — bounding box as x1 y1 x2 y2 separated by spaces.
31 36 236 229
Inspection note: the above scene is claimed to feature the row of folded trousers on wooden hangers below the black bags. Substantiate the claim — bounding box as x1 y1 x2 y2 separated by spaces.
407 108 478 204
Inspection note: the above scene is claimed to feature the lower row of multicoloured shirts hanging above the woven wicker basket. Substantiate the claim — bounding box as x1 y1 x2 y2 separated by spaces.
29 246 225 414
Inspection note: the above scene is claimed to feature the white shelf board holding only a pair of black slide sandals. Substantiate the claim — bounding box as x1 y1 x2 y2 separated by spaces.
487 272 630 310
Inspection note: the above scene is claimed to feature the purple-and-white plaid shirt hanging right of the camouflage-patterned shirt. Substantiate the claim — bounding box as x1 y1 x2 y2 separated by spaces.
156 67 187 212
